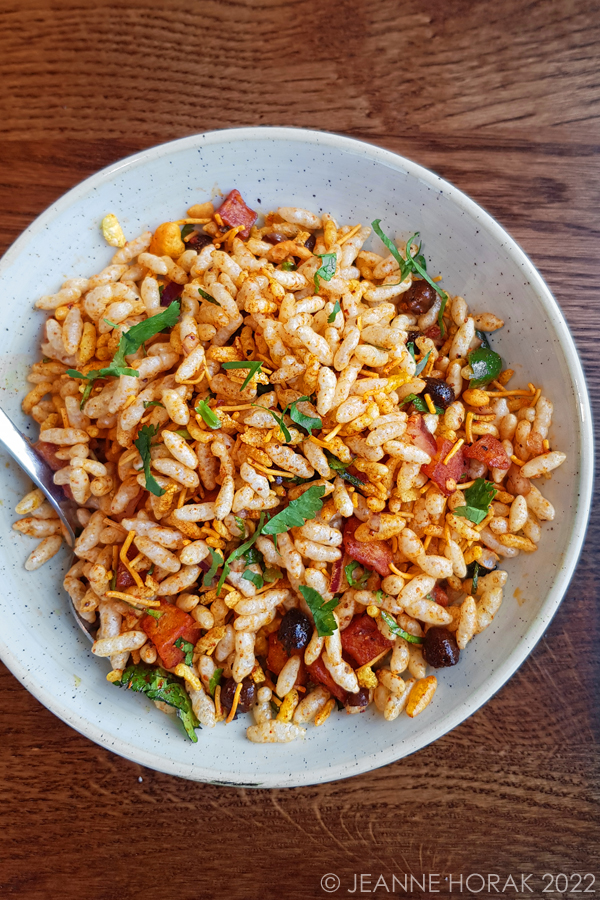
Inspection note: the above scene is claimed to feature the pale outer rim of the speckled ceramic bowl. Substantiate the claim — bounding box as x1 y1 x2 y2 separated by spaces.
0 126 594 788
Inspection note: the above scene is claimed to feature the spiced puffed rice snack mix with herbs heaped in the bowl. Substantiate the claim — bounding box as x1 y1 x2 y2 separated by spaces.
15 190 565 742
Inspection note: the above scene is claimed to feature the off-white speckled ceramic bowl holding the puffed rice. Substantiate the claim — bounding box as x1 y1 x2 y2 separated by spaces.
0 128 593 787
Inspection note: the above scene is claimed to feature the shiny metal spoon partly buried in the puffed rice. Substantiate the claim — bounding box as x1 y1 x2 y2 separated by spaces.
0 409 94 640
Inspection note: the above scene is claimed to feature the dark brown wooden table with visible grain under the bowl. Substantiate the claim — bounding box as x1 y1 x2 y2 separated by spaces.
0 0 600 900
